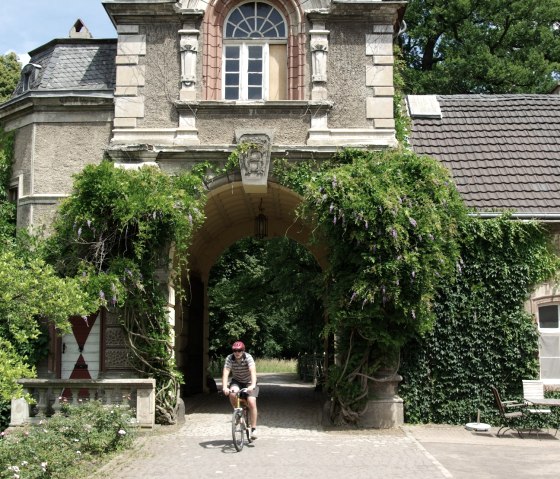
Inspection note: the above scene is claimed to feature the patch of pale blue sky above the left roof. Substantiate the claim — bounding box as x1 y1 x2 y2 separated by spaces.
0 0 117 64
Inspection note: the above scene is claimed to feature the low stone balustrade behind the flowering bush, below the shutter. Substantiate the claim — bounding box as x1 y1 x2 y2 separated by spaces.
10 379 156 428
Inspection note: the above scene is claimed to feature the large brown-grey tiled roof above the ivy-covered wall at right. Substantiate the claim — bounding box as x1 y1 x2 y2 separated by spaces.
410 95 560 216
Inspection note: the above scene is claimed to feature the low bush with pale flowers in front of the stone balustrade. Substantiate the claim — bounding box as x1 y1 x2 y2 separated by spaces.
0 401 135 479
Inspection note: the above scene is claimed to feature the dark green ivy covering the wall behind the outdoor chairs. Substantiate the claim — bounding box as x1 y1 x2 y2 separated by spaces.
399 217 560 424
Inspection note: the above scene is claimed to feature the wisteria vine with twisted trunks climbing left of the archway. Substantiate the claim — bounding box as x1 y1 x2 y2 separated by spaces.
49 161 205 423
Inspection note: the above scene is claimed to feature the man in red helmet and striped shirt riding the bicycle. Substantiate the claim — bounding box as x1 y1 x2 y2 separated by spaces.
222 341 259 439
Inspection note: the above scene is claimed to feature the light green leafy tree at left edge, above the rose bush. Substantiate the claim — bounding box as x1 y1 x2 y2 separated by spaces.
0 124 98 411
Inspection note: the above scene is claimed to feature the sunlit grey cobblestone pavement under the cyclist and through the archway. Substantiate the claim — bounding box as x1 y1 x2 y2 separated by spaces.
93 375 560 479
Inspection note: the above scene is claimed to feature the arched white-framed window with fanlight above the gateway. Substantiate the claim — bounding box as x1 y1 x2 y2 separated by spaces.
222 2 287 100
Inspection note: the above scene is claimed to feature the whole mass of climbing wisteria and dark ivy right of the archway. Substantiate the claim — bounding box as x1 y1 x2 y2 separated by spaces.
275 150 559 423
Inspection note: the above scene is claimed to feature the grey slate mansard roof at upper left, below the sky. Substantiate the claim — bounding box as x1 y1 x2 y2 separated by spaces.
13 39 117 96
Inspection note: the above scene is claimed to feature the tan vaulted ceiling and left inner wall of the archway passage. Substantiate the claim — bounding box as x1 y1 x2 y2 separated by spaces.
175 178 326 395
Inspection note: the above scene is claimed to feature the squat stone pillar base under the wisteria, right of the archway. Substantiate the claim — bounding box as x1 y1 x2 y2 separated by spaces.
358 374 404 429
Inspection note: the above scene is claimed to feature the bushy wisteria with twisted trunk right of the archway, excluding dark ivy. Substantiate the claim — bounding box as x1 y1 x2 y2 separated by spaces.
275 150 466 421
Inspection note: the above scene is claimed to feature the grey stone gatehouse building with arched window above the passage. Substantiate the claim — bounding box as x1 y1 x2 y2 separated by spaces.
0 0 405 426
